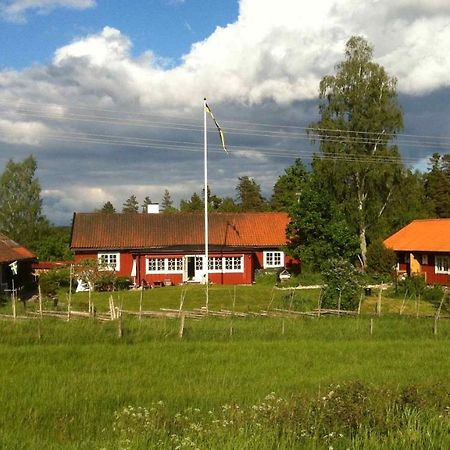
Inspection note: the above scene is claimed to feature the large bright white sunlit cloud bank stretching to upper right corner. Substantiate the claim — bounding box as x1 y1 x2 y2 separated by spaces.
37 0 450 107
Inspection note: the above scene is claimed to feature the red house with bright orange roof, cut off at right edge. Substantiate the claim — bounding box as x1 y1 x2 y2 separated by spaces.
384 219 450 285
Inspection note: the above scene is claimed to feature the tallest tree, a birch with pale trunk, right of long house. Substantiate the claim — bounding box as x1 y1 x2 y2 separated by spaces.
311 36 403 268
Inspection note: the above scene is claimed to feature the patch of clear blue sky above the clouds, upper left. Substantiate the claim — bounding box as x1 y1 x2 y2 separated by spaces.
0 0 238 69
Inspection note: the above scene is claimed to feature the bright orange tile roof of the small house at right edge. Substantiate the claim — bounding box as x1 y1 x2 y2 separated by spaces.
384 219 450 252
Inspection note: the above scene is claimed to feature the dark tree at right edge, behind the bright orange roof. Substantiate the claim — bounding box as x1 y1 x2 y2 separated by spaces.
425 153 450 217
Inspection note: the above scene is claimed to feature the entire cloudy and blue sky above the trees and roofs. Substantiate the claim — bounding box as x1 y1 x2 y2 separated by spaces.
0 0 450 224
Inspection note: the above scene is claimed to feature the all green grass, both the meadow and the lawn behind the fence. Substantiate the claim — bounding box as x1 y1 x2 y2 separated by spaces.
0 284 450 449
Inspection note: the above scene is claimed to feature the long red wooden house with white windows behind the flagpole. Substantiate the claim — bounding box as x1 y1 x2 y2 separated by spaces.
71 212 293 285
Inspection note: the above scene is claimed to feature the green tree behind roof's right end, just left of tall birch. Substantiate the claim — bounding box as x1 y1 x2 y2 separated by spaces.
270 159 308 211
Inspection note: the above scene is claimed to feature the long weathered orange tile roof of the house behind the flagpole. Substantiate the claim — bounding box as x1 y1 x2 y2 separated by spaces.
71 212 289 250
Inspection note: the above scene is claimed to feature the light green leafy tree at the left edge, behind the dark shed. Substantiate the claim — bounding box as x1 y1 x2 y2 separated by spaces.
0 155 48 250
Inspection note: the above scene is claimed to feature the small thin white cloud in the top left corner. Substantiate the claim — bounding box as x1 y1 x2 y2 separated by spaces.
0 0 96 23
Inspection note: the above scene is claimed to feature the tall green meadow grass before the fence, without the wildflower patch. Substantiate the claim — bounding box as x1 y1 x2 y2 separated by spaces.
0 317 450 449
